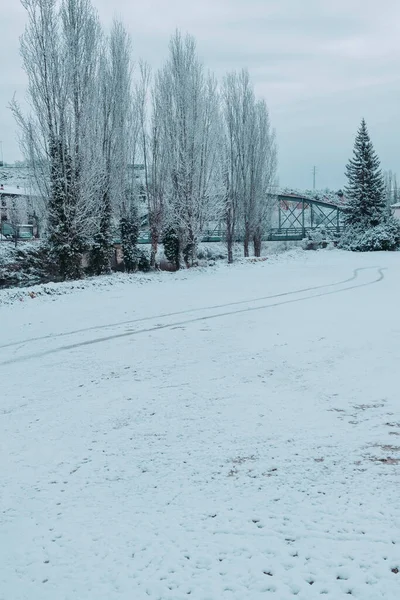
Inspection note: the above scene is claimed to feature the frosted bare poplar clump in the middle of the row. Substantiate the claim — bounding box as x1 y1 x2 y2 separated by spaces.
156 32 222 264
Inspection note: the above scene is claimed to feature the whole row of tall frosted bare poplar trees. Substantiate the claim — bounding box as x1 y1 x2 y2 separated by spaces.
11 0 277 278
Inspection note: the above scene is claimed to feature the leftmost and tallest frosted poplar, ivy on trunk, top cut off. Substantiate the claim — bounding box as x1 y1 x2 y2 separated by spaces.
11 0 100 277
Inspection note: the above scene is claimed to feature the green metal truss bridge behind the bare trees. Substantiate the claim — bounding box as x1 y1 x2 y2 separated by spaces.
135 194 345 244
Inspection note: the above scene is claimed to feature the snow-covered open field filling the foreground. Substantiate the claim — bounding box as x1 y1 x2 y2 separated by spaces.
0 251 400 600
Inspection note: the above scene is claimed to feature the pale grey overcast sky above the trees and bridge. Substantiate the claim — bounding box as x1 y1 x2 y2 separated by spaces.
0 0 400 189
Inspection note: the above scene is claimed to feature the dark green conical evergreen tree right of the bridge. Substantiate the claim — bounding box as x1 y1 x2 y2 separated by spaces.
345 119 388 231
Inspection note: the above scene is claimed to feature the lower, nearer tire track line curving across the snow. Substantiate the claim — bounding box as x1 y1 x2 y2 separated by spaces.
0 267 385 366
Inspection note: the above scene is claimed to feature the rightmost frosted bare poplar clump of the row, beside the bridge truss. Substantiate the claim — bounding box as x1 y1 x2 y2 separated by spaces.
223 70 276 262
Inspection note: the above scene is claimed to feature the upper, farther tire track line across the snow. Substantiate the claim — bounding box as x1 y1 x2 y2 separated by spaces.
0 267 379 352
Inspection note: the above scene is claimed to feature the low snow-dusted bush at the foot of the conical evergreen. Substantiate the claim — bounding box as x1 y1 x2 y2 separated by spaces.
339 218 400 252
